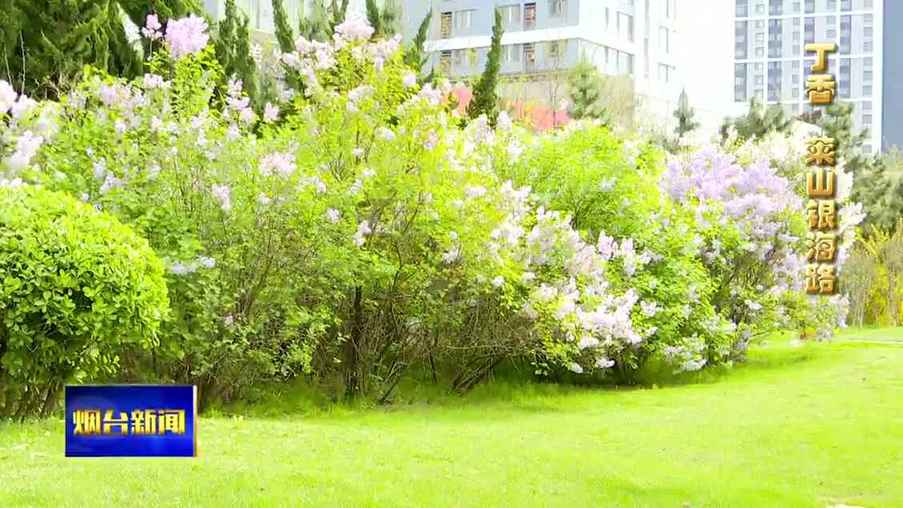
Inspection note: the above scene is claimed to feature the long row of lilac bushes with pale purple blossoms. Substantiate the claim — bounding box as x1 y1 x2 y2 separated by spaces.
0 18 858 414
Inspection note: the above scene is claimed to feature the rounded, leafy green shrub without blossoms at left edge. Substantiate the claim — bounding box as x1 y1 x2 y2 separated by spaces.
0 186 169 417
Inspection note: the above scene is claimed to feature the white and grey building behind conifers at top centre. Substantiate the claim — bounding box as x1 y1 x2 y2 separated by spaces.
402 0 680 127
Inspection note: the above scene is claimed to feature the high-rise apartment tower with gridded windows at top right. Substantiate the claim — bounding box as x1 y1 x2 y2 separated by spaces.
734 0 888 151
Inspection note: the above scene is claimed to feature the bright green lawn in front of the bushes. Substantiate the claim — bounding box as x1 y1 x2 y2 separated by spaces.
0 329 903 507
